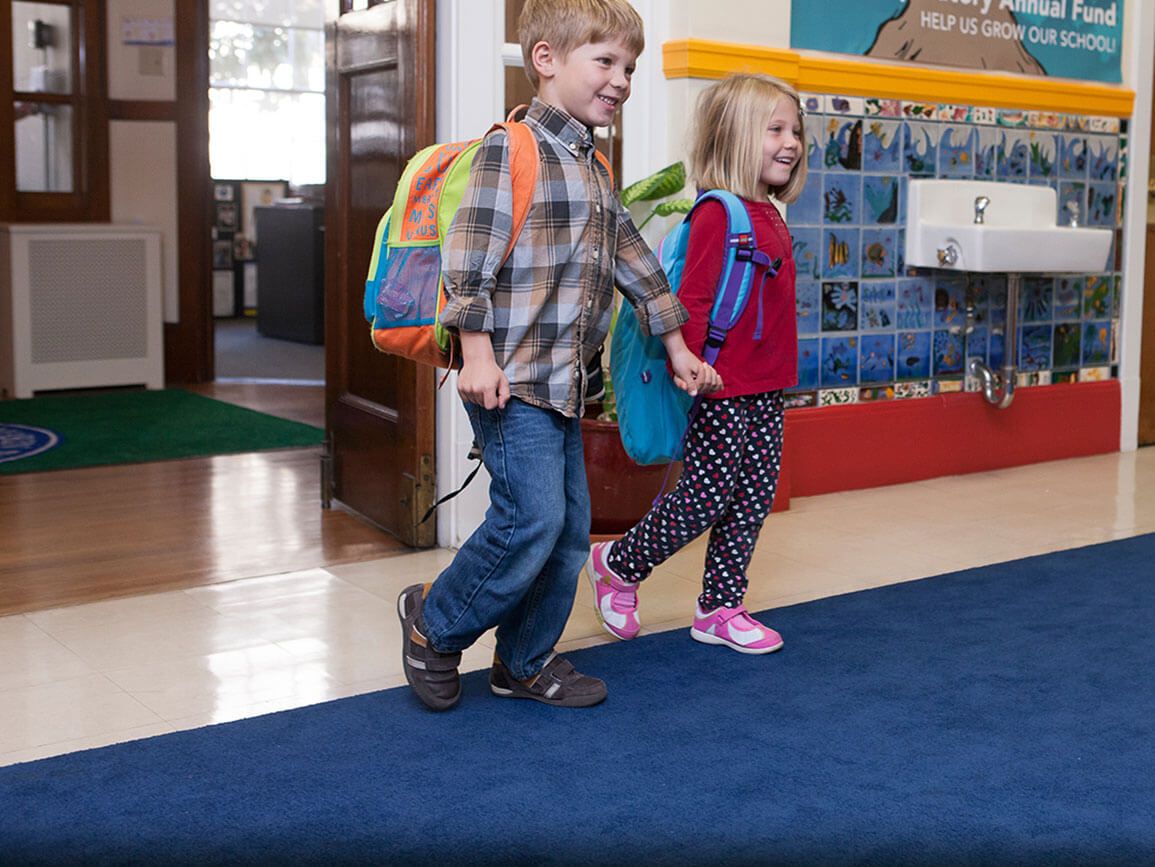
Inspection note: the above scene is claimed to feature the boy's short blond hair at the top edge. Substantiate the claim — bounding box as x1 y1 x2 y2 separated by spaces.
517 0 646 89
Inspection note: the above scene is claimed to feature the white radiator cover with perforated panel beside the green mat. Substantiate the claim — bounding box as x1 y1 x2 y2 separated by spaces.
0 224 164 397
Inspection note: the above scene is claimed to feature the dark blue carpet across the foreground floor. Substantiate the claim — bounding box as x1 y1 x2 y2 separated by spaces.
0 536 1155 865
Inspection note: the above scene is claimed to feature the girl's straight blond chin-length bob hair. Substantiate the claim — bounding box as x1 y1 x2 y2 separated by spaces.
690 74 806 204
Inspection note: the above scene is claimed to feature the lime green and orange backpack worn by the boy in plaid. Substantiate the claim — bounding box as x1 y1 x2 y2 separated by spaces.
364 107 612 368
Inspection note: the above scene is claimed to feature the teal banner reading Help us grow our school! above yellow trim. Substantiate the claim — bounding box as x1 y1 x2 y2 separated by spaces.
790 0 1124 83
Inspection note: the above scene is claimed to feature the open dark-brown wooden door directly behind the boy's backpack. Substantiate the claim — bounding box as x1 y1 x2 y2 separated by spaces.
323 0 437 547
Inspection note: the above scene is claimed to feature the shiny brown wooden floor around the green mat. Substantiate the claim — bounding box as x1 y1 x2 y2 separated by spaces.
0 383 410 615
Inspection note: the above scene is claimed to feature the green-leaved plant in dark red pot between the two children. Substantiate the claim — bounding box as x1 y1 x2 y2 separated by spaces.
581 162 694 536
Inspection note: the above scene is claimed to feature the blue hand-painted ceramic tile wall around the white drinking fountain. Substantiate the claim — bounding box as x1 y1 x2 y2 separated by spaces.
787 94 1126 406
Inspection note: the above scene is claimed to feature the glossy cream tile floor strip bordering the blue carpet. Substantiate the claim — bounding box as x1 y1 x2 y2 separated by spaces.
0 449 1155 764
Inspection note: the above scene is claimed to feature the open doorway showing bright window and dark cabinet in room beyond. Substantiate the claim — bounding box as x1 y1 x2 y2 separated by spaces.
209 0 326 386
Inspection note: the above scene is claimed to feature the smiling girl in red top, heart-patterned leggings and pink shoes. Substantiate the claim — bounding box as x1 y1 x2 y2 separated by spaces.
586 75 806 653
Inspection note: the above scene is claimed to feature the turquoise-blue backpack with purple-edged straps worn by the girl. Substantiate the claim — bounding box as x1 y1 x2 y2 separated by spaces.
610 189 782 464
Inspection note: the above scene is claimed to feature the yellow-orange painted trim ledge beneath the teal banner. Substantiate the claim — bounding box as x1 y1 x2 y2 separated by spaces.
662 39 1135 118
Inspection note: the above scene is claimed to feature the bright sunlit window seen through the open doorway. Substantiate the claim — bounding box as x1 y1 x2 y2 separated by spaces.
209 0 325 185
